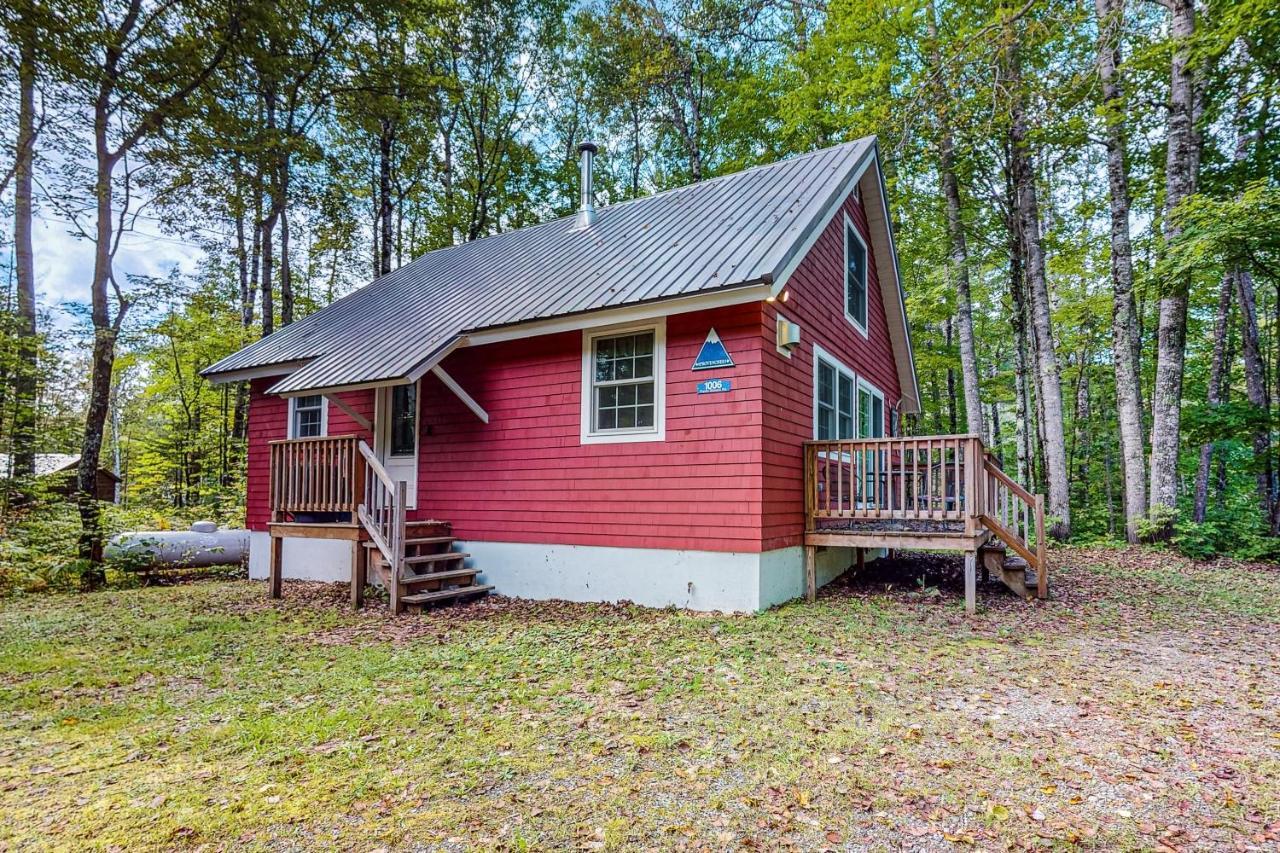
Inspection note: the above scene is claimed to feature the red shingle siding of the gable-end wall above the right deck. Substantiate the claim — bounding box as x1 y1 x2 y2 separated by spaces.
762 197 901 551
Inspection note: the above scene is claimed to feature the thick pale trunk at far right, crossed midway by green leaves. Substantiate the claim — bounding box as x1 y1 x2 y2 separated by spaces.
1149 0 1199 525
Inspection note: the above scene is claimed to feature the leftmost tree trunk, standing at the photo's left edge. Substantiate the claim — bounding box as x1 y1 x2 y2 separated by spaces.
10 16 40 478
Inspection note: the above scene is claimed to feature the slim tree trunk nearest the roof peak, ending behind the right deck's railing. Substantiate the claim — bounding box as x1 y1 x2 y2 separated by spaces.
928 0 986 435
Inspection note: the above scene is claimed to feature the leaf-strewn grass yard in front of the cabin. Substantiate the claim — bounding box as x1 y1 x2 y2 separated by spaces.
0 549 1280 850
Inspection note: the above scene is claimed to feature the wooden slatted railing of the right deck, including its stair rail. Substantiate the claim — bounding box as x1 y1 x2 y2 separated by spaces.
804 435 1048 597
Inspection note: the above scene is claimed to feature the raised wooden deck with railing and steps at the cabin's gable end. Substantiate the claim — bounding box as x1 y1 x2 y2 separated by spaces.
804 435 1048 612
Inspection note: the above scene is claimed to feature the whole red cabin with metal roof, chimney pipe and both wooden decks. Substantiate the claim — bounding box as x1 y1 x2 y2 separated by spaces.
205 138 1044 611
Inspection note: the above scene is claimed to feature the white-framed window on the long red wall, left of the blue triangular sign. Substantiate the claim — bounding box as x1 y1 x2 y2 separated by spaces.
582 315 666 443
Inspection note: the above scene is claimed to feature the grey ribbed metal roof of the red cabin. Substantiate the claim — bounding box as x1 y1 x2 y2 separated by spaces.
202 137 876 393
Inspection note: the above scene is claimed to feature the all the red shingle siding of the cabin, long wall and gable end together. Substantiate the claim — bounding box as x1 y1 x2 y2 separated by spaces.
238 185 900 552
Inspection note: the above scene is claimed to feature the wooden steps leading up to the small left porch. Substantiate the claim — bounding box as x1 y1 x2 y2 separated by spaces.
365 521 493 612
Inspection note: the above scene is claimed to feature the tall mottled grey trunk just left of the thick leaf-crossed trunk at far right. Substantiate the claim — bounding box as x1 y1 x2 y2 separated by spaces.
1096 0 1147 543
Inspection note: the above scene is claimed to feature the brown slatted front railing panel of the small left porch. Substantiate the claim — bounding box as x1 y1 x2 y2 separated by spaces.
270 435 365 514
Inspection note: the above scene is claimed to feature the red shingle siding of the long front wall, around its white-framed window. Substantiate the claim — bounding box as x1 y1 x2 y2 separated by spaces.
419 305 762 551
